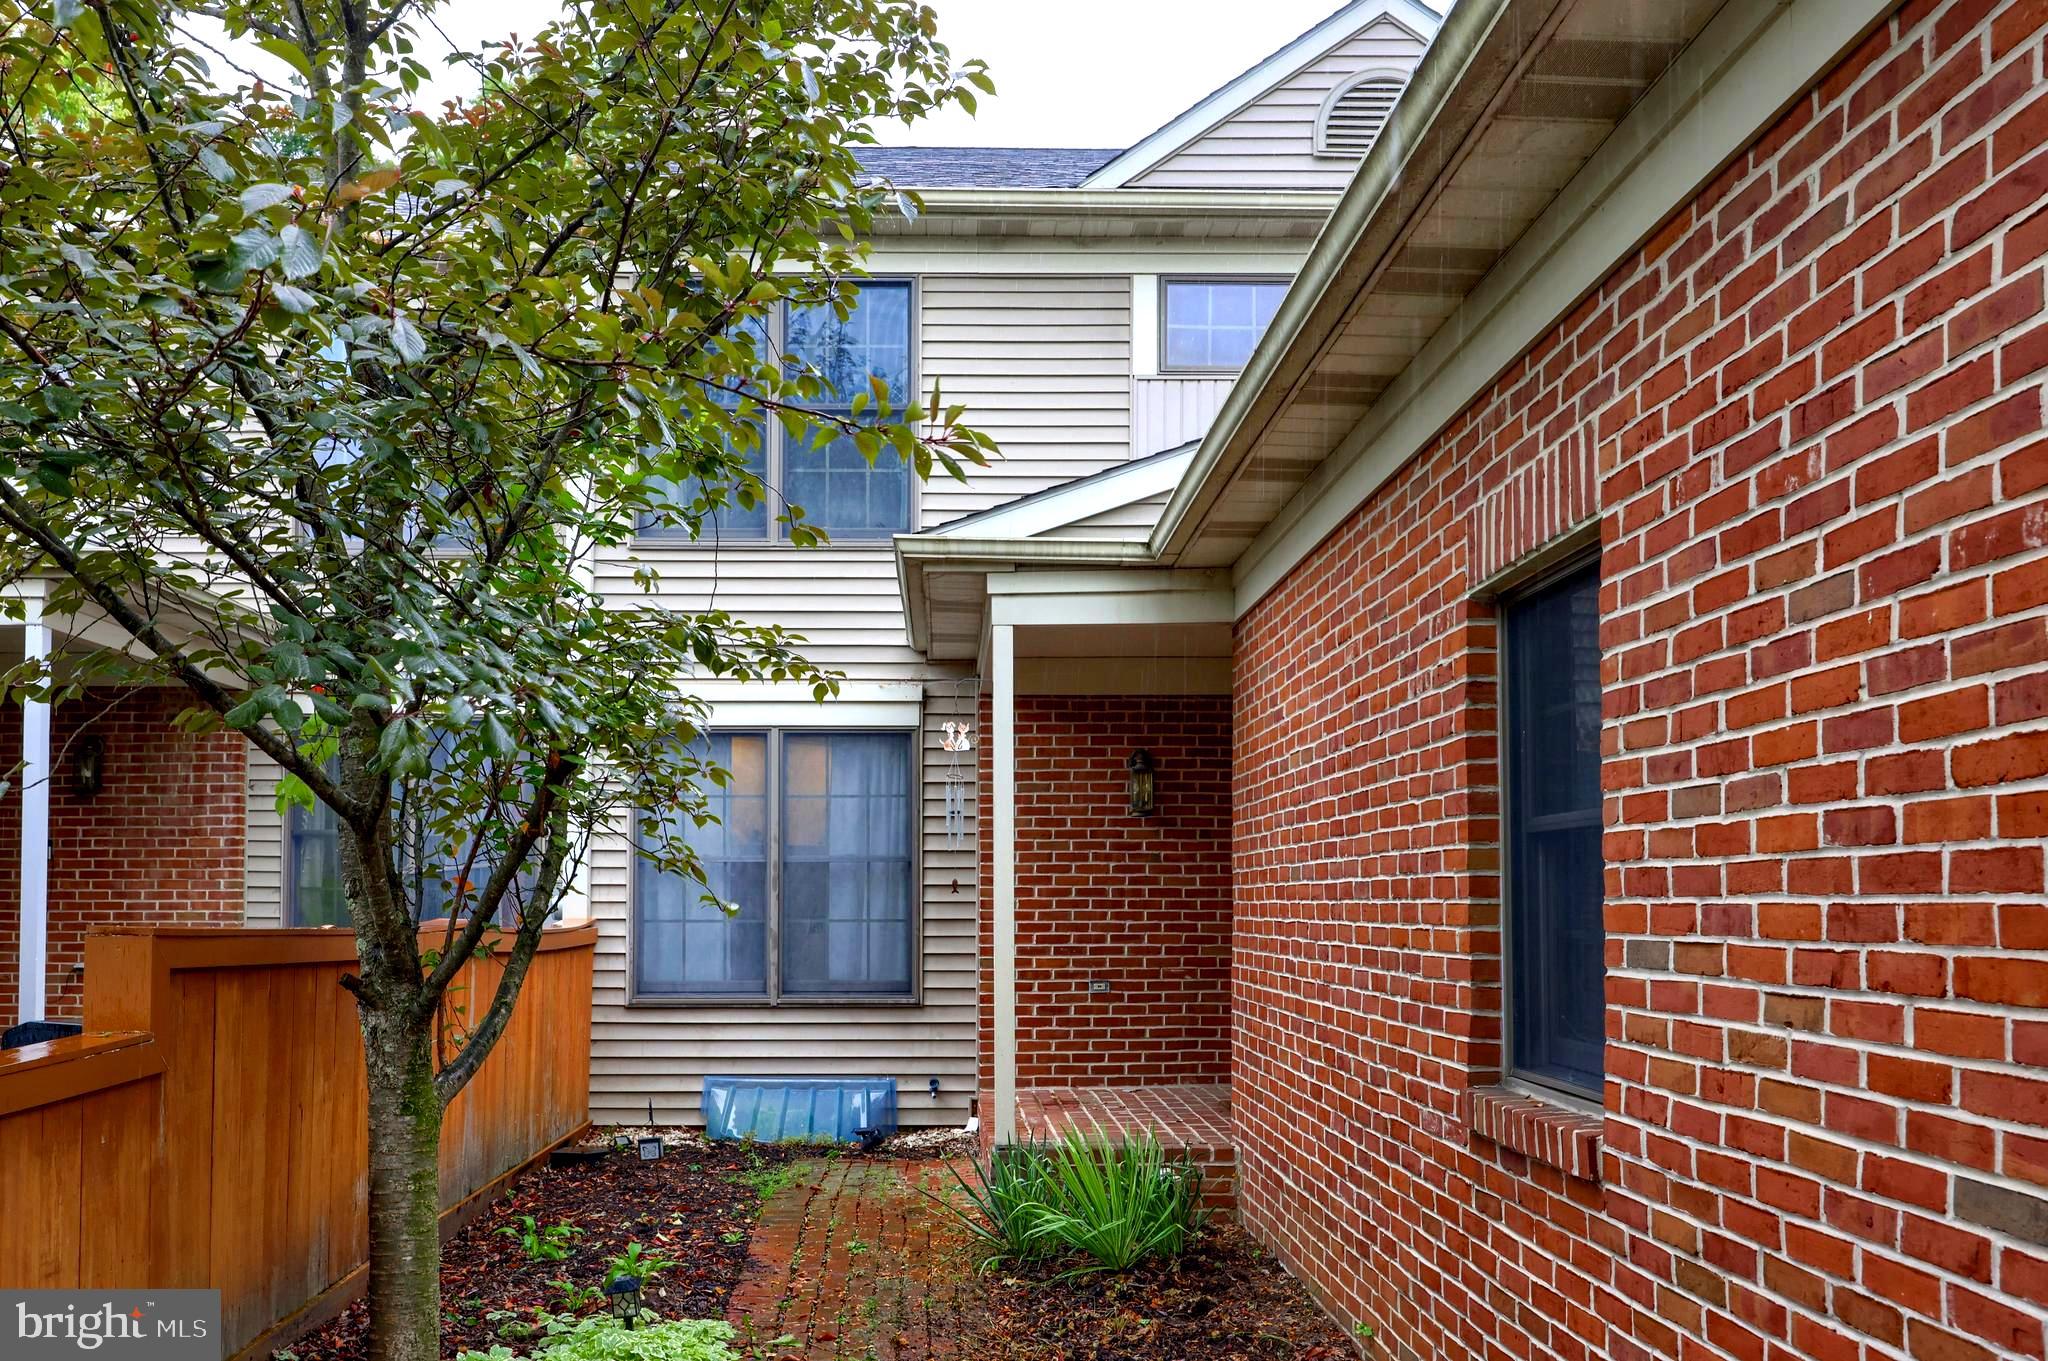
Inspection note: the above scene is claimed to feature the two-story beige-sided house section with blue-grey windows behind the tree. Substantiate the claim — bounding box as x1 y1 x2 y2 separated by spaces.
220 0 1440 1126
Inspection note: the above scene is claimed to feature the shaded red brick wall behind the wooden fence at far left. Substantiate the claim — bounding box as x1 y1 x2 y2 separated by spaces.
0 686 246 1025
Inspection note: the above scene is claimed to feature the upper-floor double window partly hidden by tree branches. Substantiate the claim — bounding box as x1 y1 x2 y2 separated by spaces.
641 278 915 542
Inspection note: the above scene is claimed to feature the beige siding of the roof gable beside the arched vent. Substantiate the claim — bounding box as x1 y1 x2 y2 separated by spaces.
1130 18 1425 190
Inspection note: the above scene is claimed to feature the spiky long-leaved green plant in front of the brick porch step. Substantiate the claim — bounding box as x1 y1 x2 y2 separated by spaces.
940 1130 1206 1275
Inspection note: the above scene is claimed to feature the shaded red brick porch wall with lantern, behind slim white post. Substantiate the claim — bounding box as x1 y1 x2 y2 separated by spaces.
981 696 1231 1089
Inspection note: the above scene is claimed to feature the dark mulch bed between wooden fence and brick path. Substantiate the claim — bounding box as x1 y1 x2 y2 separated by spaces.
291 1142 817 1361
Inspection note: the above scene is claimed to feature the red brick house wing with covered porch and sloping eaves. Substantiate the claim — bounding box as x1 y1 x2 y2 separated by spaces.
913 0 2048 1361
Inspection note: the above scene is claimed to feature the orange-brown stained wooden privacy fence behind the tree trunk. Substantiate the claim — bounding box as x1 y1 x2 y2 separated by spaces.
0 923 596 1353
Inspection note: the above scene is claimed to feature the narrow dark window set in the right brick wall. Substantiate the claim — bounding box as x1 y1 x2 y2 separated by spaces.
1501 563 1606 1099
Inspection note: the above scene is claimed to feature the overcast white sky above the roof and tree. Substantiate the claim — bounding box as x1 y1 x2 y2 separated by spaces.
203 0 1376 147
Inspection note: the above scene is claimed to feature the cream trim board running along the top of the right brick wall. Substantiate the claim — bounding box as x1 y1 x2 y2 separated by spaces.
1220 0 1894 612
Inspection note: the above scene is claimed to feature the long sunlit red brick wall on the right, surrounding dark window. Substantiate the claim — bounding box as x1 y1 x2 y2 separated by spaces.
1233 0 2048 1361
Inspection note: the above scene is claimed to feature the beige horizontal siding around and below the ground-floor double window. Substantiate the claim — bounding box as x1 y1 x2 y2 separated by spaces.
590 682 975 1126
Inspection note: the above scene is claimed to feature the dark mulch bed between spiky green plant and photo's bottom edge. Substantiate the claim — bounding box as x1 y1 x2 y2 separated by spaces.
954 1220 1358 1361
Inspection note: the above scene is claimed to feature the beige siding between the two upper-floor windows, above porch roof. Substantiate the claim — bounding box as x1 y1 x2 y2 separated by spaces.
920 274 1130 528
